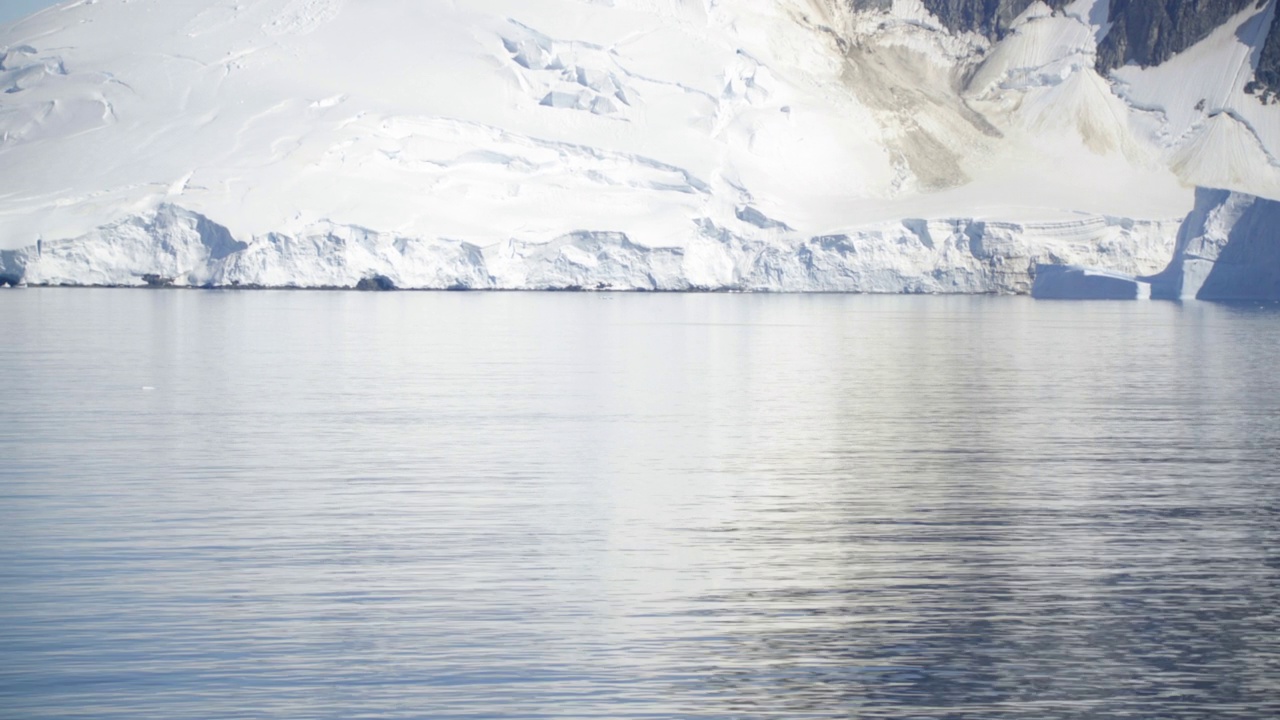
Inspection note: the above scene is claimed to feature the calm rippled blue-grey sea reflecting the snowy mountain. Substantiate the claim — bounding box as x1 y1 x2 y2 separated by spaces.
0 290 1280 719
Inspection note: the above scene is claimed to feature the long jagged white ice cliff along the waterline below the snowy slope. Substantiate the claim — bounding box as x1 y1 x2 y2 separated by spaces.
0 205 1175 293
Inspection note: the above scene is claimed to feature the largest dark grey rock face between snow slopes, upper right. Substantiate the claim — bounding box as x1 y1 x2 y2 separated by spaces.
1098 0 1256 74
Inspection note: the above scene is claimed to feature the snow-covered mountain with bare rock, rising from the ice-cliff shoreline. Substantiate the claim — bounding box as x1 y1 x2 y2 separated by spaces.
0 0 1280 292
